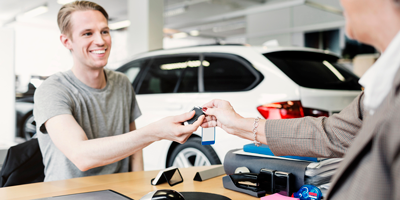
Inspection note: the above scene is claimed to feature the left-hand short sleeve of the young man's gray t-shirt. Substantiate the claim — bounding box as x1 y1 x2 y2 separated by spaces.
33 80 72 134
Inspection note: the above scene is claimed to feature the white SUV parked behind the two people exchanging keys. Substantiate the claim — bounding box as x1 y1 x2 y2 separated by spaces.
117 45 361 170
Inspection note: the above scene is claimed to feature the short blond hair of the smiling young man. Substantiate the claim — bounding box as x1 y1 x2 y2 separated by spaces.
57 1 108 36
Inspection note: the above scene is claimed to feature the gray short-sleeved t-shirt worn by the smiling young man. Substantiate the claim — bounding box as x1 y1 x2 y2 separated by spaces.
34 69 141 181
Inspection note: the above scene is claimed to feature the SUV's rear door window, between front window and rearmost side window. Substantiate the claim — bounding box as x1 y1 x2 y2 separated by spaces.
138 55 200 94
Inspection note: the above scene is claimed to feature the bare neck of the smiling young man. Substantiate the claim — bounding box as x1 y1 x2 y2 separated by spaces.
71 66 107 89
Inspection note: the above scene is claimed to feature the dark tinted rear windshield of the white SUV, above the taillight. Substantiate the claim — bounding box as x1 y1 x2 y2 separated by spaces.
263 51 361 90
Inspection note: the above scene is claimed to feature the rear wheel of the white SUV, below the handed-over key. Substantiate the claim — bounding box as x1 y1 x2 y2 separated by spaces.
168 137 221 168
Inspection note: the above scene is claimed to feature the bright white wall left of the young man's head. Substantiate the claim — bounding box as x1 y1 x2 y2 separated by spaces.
13 23 72 91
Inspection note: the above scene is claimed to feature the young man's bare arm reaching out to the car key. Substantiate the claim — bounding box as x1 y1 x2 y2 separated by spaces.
45 112 204 171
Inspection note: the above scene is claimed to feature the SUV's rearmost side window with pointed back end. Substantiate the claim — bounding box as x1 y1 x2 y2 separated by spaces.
203 56 257 92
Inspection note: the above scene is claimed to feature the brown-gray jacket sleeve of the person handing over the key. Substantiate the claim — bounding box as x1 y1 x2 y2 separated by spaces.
265 92 366 158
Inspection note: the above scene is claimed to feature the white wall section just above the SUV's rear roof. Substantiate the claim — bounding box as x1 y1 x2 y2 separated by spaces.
246 3 345 46
